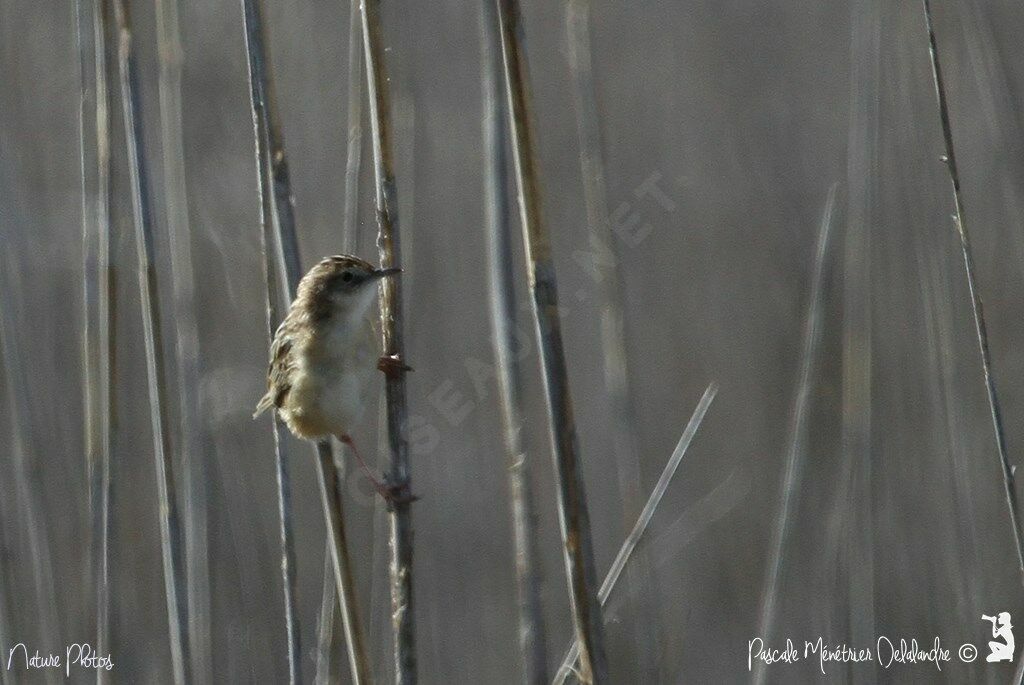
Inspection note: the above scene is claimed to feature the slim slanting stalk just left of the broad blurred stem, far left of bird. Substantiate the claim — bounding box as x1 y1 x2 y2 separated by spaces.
114 0 193 684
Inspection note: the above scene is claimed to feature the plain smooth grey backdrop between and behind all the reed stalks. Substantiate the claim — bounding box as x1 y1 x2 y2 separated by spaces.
0 0 1024 683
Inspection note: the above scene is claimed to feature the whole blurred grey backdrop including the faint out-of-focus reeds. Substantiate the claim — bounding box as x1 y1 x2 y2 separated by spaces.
0 0 1024 683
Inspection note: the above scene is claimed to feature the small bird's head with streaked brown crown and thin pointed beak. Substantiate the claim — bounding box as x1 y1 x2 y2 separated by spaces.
298 255 401 319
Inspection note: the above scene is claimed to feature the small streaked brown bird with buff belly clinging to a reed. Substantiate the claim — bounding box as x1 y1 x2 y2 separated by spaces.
253 255 408 501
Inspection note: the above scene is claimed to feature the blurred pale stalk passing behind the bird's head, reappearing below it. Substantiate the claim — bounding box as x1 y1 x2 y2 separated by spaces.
316 0 370 684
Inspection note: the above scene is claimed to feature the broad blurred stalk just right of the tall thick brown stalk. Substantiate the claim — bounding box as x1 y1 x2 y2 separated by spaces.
565 0 662 681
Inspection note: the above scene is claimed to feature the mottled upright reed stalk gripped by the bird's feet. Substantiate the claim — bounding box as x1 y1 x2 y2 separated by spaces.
361 0 417 685
